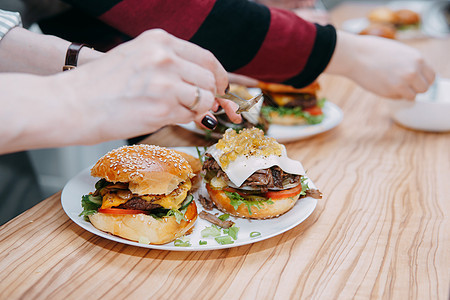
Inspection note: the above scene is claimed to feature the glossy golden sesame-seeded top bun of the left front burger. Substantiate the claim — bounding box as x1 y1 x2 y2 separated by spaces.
91 145 195 195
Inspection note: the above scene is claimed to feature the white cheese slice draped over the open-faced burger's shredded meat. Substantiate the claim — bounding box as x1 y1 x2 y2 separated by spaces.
206 145 305 187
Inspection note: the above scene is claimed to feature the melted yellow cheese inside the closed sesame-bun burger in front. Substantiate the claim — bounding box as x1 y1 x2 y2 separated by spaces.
101 179 192 209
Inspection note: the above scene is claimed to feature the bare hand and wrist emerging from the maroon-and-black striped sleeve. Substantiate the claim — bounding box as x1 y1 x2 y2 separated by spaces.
326 32 435 100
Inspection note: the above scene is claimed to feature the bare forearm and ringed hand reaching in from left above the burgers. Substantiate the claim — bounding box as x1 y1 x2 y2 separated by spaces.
0 30 237 154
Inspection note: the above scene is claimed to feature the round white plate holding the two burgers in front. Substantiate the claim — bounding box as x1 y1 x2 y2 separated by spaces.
61 147 317 251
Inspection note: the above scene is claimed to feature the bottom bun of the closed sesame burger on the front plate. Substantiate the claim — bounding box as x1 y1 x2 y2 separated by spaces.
89 201 197 245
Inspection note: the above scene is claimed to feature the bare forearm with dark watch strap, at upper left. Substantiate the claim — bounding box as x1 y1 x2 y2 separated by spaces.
0 27 102 75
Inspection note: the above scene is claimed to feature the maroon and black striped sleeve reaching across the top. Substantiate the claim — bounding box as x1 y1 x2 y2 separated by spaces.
66 0 336 87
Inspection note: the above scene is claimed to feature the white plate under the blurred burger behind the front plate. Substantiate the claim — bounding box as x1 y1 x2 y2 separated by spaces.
178 101 344 143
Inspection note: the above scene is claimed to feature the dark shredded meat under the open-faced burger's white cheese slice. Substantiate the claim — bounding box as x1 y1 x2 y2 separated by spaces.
203 153 301 193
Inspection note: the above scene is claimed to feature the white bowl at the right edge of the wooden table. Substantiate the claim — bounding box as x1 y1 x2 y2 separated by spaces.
392 78 450 132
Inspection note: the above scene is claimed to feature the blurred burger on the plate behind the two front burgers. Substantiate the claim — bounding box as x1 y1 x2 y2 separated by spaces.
259 81 326 125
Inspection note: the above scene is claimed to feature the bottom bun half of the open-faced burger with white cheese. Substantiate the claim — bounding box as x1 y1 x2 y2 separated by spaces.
206 184 300 219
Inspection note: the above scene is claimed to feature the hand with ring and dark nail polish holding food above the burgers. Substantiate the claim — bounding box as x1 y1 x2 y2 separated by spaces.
66 30 240 142
